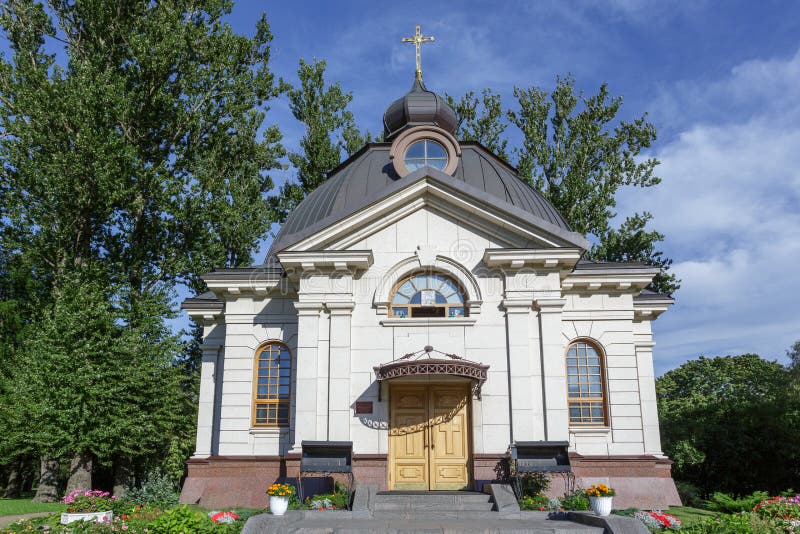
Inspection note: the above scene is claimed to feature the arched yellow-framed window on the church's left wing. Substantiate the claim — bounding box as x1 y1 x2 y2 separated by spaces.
253 342 292 426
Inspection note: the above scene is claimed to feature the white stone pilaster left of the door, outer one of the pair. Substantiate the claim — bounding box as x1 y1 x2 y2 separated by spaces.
292 302 325 452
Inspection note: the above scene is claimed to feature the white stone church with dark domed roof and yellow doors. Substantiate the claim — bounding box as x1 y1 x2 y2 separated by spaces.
182 70 680 508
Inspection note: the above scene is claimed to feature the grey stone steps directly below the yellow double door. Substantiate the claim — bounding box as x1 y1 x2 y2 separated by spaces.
371 491 497 519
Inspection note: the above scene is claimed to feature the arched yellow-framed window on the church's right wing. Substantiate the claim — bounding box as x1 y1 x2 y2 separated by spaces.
567 341 607 426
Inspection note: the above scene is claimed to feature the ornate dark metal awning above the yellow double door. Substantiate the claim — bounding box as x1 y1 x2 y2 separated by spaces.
373 345 489 399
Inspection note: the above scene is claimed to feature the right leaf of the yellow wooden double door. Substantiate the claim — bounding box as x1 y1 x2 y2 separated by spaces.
429 387 470 490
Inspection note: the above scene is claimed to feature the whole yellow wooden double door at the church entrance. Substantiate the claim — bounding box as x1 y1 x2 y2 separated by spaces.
389 384 471 490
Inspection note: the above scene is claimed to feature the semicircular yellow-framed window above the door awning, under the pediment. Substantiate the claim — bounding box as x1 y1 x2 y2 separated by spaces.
390 273 469 318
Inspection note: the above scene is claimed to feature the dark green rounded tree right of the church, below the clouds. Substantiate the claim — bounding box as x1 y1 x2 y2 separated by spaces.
656 354 800 495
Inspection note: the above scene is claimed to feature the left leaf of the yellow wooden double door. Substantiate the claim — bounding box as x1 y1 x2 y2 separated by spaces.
389 386 429 490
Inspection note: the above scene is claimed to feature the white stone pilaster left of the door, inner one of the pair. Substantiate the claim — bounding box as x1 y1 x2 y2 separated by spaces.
326 301 355 441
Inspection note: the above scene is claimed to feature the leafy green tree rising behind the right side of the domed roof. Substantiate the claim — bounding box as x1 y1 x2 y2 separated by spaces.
447 77 680 293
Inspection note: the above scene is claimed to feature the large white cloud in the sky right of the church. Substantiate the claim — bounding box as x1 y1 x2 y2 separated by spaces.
620 52 800 371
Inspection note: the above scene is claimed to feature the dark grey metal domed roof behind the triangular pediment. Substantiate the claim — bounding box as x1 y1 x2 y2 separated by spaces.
266 142 588 263
